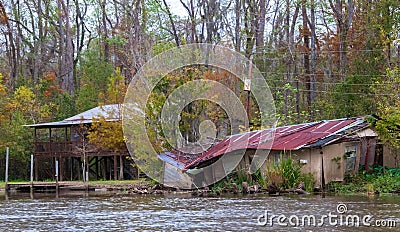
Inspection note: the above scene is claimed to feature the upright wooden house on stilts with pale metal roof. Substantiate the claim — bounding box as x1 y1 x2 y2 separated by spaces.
27 104 138 181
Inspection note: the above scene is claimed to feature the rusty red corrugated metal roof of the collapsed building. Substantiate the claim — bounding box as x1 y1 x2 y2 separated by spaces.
159 117 368 169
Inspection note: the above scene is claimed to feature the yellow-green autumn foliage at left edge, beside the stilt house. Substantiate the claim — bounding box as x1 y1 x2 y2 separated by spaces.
0 73 70 180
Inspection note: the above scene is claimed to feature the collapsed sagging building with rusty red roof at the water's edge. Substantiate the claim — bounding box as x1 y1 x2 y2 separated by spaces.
159 117 384 188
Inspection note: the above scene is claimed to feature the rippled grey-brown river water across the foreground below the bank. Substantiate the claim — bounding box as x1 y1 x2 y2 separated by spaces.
0 193 400 231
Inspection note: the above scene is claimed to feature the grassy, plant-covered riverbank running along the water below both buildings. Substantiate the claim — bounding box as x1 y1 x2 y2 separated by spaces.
0 167 400 196
